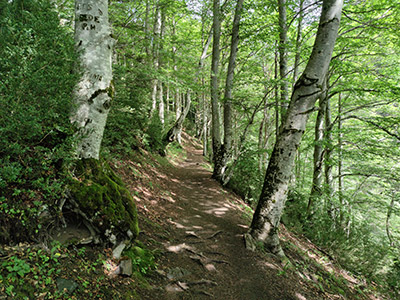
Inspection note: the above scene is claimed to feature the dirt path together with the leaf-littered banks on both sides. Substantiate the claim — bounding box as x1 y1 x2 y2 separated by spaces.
111 135 383 300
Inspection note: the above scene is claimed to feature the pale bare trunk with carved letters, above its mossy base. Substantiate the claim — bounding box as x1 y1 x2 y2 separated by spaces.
71 0 114 159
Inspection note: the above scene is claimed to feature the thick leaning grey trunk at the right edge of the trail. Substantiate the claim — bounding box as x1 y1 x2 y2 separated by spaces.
245 0 343 257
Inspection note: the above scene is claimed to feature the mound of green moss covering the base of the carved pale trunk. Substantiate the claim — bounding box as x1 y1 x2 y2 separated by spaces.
70 159 139 237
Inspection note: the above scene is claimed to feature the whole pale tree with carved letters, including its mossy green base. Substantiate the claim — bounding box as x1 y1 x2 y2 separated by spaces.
68 0 139 243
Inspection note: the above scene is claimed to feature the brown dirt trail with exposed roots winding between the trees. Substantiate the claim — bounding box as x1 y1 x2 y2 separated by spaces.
136 136 324 300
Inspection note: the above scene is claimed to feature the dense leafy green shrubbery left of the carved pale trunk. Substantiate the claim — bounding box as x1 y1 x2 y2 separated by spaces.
0 0 77 242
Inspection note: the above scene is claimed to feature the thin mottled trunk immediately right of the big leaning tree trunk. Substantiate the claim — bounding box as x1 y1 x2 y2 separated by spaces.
307 79 328 219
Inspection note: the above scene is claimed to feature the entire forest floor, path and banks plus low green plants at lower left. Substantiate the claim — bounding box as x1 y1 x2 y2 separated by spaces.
0 135 388 300
